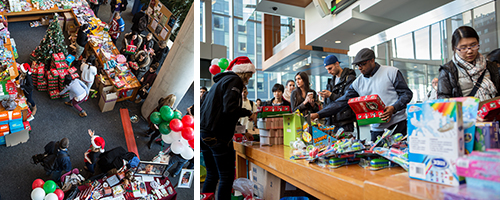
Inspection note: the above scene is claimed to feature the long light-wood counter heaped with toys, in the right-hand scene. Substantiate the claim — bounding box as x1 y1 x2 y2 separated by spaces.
234 142 448 200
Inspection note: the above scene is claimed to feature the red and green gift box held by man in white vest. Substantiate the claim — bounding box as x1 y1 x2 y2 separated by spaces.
348 94 387 126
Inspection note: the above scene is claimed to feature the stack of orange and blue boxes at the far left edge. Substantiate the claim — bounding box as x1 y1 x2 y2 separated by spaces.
0 110 24 145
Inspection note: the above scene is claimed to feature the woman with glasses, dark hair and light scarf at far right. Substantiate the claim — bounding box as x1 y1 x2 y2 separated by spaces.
437 26 500 101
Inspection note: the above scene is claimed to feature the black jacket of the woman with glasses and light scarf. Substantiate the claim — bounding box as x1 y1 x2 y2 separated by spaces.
437 61 500 99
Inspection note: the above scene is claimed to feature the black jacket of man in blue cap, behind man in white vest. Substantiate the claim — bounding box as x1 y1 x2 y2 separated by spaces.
325 68 356 126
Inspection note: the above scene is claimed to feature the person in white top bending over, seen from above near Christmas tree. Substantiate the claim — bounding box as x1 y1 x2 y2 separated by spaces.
59 75 89 117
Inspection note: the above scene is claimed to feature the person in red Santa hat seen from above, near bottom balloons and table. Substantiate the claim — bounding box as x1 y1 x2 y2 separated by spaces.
83 129 106 175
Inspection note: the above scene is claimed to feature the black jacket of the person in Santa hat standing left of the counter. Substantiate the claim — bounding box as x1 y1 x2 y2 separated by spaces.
200 72 252 142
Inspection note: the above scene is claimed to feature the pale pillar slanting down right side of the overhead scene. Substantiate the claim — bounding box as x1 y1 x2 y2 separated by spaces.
141 3 195 118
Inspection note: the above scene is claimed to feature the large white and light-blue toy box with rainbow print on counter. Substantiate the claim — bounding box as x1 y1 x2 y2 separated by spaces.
406 101 465 186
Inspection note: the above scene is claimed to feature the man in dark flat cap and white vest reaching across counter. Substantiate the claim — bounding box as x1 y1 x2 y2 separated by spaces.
311 48 413 141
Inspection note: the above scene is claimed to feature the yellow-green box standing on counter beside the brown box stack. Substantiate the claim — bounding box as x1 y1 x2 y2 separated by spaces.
283 113 303 146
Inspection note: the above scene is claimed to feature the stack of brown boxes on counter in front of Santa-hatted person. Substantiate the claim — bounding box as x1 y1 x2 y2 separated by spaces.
257 117 283 145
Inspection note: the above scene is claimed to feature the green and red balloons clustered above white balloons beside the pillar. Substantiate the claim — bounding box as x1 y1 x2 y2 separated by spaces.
149 106 194 144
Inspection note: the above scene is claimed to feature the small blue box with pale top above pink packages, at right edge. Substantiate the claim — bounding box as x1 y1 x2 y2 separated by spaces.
474 122 500 151
